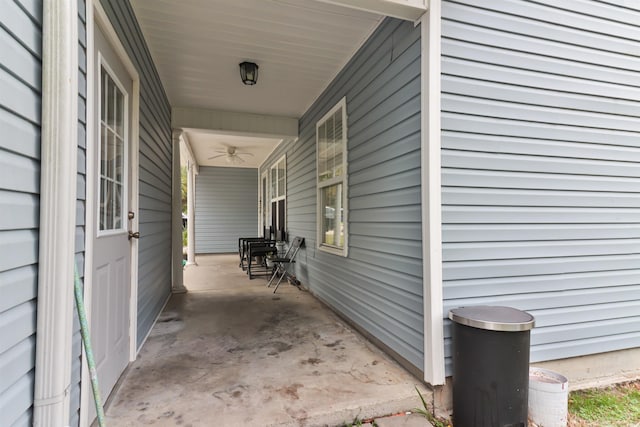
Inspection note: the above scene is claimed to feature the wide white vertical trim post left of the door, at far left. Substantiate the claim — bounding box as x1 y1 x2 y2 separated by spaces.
33 0 78 427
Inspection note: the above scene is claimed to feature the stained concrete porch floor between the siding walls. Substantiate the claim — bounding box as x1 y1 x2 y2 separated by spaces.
107 255 431 427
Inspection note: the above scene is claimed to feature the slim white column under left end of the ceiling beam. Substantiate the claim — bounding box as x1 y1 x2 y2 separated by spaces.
171 129 187 294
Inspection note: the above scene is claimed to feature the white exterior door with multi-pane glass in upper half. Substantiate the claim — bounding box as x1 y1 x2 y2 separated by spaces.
88 25 135 400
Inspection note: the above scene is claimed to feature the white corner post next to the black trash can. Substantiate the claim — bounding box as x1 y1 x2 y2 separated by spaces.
420 0 445 385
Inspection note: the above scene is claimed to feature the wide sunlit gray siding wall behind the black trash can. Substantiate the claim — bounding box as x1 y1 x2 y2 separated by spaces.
442 0 640 373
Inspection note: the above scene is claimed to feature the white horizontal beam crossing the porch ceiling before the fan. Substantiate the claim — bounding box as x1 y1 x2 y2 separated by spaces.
171 107 298 139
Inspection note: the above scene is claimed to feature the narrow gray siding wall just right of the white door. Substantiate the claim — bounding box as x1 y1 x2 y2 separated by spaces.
101 0 171 346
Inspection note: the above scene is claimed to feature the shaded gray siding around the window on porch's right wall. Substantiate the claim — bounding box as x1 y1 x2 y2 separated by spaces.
263 19 424 370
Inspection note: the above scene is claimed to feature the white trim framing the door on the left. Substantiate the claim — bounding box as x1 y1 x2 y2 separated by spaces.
80 0 140 427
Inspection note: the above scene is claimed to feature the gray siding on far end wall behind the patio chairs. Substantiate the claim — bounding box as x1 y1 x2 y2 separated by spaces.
195 166 258 253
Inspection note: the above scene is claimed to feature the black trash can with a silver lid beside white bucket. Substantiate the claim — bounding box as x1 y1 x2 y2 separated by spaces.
449 306 535 427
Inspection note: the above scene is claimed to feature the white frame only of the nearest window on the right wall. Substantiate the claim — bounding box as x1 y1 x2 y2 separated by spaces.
316 97 349 257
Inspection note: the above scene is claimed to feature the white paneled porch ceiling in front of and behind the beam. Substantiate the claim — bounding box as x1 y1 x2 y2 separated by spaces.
131 0 382 167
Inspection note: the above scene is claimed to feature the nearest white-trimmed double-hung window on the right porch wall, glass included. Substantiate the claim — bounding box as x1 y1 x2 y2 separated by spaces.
316 98 348 256
